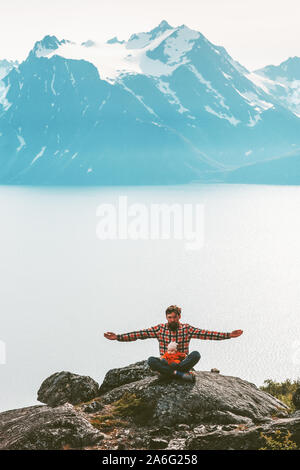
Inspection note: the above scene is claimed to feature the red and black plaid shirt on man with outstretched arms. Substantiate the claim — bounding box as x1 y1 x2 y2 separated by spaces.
117 323 230 356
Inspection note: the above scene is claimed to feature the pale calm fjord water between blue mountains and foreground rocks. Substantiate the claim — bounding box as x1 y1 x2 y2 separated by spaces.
0 185 300 410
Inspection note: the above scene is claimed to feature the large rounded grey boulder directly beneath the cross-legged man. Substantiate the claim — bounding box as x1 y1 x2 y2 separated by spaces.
96 365 287 426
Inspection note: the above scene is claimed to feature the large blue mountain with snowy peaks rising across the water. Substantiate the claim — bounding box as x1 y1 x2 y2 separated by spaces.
0 21 300 184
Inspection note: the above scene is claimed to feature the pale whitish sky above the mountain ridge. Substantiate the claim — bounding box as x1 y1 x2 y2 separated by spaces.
0 0 300 70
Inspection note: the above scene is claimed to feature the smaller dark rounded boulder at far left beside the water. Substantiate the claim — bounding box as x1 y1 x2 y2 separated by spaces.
37 371 99 406
